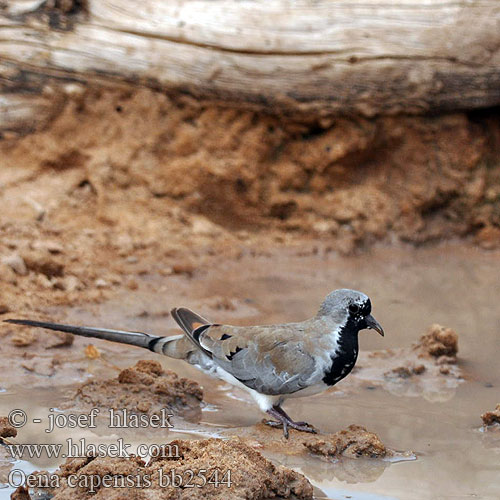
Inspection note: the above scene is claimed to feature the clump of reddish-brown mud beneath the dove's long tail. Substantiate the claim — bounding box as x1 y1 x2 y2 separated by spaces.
76 360 203 415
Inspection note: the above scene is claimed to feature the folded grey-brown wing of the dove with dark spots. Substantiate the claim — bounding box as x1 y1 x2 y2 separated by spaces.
198 323 316 395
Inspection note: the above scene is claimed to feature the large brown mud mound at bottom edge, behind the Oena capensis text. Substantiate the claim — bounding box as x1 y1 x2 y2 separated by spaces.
15 439 313 500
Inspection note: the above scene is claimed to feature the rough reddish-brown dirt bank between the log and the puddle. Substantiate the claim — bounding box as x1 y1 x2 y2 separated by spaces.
0 90 500 312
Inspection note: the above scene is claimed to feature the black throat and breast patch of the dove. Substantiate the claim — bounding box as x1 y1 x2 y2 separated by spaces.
323 318 359 386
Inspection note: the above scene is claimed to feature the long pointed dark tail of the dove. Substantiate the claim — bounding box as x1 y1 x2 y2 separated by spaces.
4 319 183 355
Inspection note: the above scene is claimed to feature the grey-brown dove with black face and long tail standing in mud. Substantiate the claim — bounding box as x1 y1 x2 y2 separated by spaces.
4 288 384 439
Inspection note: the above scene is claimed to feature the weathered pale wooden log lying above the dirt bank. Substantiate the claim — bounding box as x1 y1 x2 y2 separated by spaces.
0 0 500 130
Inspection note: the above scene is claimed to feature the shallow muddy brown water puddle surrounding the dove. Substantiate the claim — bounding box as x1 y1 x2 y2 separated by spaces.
0 246 500 500
